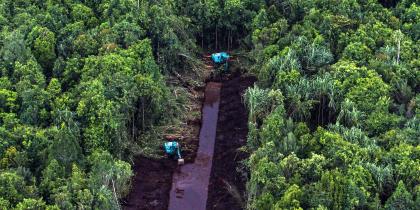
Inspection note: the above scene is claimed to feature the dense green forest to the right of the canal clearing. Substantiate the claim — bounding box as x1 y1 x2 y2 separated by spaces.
245 0 420 209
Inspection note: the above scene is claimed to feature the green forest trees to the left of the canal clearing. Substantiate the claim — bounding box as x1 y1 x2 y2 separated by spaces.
0 0 201 209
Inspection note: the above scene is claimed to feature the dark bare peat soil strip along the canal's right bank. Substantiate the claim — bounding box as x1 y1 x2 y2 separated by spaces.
207 69 256 210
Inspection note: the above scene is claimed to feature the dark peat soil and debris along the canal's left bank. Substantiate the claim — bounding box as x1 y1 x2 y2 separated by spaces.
121 87 204 210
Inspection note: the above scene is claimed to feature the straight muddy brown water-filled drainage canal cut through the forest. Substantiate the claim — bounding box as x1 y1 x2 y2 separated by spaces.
168 82 222 210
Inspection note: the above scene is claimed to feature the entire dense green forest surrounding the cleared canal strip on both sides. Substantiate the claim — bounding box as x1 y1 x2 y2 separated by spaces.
0 0 420 210
